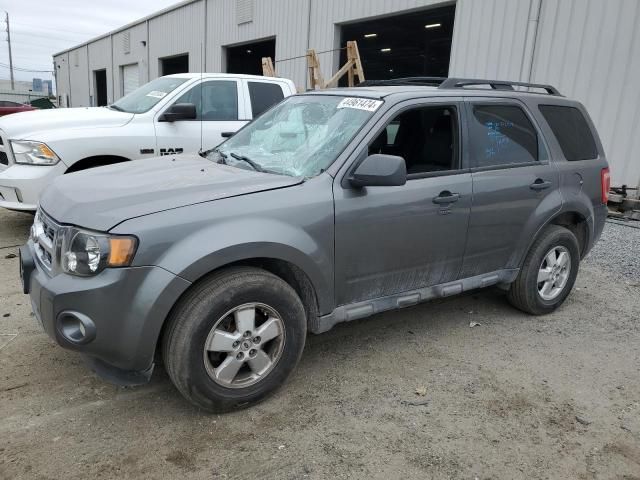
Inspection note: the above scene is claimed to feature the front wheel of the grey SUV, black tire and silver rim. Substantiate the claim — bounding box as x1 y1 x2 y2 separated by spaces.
163 267 307 412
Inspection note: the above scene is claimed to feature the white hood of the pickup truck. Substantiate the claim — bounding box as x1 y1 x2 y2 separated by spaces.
0 107 133 140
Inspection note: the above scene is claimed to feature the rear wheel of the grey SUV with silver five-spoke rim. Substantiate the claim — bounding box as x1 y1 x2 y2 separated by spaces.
507 225 580 315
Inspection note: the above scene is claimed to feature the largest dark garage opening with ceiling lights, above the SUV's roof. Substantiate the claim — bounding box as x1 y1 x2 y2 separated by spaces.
340 5 456 82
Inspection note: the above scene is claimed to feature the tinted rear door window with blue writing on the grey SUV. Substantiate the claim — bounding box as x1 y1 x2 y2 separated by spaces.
470 105 538 167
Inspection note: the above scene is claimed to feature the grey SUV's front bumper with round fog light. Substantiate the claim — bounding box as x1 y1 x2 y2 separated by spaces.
20 240 191 385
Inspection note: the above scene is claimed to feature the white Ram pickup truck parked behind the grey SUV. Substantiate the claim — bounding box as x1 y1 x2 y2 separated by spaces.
0 73 296 211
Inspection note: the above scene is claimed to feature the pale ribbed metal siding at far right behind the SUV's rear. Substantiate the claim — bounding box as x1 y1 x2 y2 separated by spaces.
532 0 640 186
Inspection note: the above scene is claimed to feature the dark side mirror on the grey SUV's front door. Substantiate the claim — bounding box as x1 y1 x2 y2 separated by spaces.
349 153 407 188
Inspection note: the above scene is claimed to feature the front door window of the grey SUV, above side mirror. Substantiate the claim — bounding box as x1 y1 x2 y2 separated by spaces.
369 106 458 174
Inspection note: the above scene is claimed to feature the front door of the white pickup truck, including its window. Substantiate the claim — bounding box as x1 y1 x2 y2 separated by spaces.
154 78 249 155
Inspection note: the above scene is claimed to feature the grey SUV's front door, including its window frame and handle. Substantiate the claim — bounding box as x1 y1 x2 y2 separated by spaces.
334 102 472 305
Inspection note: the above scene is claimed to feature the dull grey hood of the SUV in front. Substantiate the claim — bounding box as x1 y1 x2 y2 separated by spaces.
40 155 303 232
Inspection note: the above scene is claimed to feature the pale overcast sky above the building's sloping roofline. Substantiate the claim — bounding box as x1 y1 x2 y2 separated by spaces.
0 0 179 81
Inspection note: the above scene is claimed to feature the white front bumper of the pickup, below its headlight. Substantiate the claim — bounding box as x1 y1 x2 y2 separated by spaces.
0 162 67 211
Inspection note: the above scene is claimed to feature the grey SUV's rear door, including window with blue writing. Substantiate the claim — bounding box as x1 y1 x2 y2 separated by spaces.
462 99 562 277
